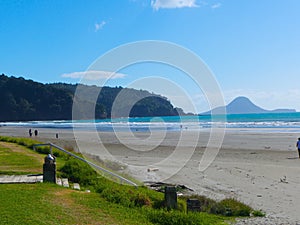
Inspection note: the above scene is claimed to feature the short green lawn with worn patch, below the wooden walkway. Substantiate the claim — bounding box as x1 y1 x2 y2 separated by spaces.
0 184 151 224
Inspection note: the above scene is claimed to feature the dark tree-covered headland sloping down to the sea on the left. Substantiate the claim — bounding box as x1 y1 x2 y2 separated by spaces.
0 74 185 122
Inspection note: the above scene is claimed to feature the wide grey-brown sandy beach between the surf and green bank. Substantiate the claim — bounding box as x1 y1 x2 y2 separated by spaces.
0 126 300 224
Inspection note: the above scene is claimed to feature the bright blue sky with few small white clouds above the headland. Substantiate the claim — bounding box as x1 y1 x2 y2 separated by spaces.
0 0 300 112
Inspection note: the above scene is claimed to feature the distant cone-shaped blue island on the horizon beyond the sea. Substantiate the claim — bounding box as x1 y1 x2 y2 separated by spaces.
202 97 296 114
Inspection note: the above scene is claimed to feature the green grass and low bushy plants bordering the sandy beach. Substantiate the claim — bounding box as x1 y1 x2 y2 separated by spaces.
0 137 262 225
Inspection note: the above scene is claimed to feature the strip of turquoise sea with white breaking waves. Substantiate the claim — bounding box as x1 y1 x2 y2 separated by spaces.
0 112 300 132
